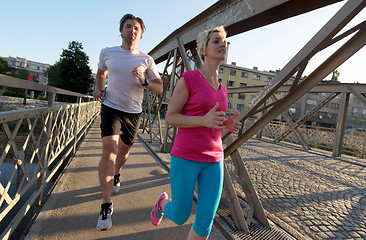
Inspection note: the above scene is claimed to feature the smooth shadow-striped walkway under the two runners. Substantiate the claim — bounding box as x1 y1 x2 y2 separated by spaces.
26 115 225 240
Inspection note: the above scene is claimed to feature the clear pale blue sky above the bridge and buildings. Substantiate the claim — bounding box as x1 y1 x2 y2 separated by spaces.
0 0 366 83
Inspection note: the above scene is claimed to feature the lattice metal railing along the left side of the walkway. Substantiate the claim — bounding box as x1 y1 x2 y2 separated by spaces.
0 74 100 239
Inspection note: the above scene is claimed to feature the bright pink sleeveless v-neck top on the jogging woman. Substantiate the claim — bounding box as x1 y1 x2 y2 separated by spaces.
170 70 228 162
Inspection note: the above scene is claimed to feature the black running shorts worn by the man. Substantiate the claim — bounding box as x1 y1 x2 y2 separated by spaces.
100 104 141 146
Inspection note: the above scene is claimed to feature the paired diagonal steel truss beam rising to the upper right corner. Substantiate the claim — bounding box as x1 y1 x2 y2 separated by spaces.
222 0 366 157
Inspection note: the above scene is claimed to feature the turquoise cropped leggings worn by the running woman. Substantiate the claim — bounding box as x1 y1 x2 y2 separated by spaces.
164 156 224 237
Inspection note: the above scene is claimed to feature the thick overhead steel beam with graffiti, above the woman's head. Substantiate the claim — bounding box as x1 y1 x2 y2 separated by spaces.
149 0 340 63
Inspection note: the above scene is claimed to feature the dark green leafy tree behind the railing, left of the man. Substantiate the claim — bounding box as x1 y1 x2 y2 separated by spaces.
46 41 94 100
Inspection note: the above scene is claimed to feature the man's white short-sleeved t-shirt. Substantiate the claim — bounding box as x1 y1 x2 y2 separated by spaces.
98 46 160 113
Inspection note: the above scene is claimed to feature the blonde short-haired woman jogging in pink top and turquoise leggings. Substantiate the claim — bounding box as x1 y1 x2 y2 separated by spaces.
151 26 241 240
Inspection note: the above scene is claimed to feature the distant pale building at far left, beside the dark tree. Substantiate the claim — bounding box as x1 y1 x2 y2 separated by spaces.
3 57 51 85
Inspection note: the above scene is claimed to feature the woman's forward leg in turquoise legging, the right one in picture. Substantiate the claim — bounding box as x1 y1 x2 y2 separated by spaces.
192 161 224 239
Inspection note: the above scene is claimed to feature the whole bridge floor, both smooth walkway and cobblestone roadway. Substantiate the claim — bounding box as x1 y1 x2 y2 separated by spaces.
27 116 366 240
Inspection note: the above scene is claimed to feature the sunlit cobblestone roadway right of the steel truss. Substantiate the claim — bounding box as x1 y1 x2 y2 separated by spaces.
234 139 366 239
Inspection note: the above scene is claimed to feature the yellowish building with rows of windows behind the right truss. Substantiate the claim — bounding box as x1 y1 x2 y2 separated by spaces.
219 63 366 131
